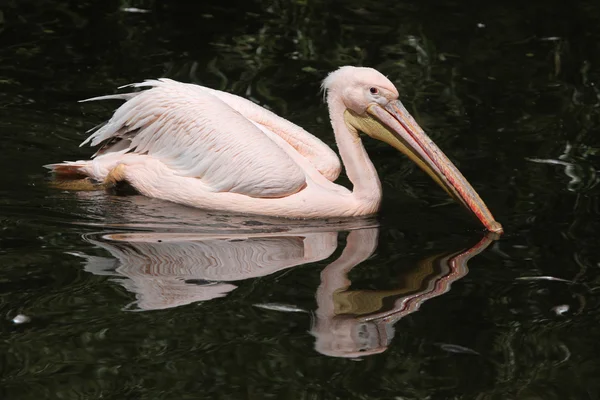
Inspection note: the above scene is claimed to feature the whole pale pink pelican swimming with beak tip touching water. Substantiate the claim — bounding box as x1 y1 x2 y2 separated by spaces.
46 66 502 233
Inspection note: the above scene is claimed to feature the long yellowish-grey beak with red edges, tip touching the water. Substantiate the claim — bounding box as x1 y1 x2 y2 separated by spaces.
365 100 503 234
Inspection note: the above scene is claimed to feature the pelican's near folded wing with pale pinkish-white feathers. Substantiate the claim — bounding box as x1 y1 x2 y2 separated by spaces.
82 79 306 197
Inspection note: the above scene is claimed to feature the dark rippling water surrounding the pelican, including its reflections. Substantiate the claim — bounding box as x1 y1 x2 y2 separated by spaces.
0 0 600 399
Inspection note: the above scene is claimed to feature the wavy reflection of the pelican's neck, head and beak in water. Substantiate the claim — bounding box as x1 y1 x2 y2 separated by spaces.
311 229 494 358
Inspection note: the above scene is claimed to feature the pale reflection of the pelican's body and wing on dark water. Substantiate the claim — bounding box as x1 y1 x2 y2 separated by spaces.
85 232 337 310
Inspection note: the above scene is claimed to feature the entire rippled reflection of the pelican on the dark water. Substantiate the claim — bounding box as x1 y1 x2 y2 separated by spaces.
78 209 493 357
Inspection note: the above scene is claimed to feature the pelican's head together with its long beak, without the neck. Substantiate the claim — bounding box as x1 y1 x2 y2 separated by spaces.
323 67 503 233
